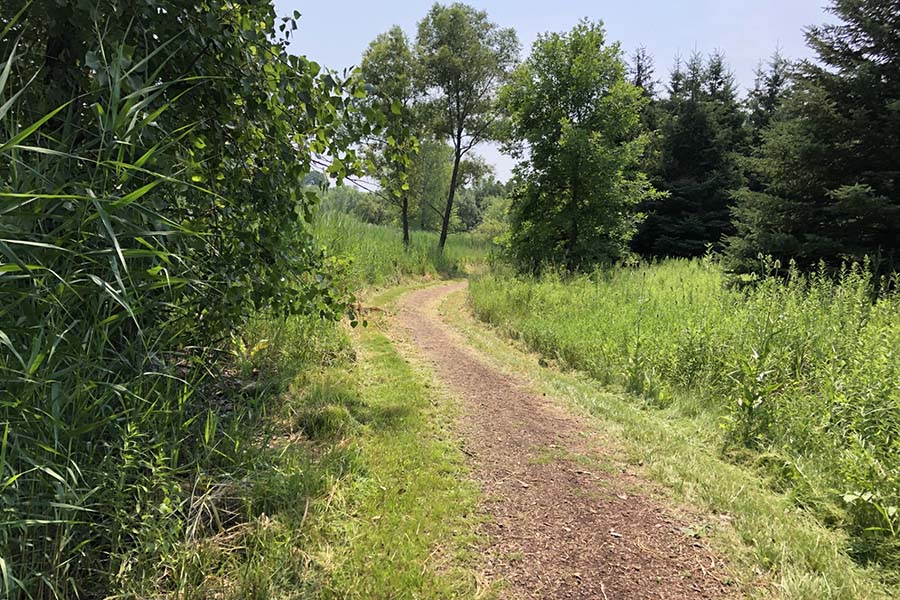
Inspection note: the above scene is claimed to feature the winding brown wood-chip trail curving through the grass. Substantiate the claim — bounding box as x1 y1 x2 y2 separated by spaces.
396 282 732 600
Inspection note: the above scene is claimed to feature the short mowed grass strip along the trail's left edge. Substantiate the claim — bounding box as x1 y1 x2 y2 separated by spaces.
327 328 484 599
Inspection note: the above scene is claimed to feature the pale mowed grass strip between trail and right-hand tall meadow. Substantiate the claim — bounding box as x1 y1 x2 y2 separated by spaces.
444 286 897 600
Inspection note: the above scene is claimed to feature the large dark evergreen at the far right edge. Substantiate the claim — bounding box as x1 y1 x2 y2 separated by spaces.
727 0 900 273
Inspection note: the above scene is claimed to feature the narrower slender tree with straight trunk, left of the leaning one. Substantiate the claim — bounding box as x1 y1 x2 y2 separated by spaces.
361 26 419 247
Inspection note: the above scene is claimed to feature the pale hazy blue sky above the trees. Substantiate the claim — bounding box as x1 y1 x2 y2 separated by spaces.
275 0 833 180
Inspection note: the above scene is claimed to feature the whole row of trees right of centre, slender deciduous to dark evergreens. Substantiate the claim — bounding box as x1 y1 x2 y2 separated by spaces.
362 0 900 275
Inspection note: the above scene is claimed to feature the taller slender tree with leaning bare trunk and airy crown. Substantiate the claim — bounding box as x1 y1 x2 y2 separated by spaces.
416 3 519 249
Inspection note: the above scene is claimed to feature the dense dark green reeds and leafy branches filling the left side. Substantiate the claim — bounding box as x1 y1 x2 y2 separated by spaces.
0 0 372 598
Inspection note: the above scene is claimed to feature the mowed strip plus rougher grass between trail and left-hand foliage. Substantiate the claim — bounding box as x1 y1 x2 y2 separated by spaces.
112 282 490 599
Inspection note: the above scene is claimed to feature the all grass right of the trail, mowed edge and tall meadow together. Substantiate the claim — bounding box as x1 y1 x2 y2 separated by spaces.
471 261 900 598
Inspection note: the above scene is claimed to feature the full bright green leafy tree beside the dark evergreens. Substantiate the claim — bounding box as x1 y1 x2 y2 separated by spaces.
503 21 654 271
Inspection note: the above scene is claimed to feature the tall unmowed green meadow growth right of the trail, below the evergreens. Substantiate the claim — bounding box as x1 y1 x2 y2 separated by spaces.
471 261 900 568
